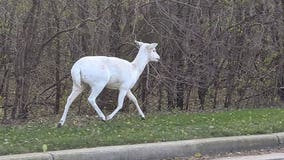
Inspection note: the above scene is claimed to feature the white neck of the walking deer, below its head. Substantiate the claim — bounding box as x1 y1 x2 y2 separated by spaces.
132 51 149 75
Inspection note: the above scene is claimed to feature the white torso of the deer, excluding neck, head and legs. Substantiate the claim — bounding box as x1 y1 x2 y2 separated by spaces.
72 56 135 89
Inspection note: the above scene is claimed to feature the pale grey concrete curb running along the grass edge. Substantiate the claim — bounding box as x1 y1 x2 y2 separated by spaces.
0 132 284 160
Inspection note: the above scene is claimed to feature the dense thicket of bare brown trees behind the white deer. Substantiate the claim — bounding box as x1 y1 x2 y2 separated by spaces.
0 0 284 122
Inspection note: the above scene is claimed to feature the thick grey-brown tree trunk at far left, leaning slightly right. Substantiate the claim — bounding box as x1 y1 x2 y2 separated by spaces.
11 0 40 119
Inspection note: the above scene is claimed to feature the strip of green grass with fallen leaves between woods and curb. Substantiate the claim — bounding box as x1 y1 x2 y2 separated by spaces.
0 109 284 155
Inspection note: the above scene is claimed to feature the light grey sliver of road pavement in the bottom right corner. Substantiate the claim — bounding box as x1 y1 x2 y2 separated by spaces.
214 153 284 160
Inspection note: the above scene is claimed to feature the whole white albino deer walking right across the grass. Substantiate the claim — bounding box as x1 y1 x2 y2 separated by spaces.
58 41 160 127
